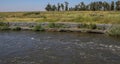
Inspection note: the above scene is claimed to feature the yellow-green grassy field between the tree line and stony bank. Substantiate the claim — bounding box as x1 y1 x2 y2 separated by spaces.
0 11 120 24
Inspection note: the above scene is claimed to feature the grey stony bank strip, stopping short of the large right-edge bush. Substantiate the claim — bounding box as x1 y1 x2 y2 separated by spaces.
0 22 112 34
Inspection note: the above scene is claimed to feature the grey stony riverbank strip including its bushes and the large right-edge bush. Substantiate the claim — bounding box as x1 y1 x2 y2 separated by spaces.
0 22 120 37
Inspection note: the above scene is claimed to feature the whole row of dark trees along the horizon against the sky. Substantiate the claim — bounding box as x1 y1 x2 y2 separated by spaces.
45 1 120 11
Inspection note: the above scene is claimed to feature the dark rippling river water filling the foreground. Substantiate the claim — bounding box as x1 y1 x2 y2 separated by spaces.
0 31 120 64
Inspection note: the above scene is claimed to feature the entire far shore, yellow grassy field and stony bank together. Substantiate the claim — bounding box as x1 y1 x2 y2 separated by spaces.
0 11 120 36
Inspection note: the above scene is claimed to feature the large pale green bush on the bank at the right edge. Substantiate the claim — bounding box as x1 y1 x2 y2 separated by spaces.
107 25 120 36
